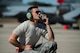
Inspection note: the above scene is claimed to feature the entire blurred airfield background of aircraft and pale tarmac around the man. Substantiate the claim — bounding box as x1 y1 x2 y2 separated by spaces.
0 0 80 53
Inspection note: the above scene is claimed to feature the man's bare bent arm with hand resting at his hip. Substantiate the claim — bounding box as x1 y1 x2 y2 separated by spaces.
8 34 32 50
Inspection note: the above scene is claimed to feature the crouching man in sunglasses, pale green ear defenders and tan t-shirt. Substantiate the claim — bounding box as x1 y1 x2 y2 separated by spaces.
8 6 57 53
